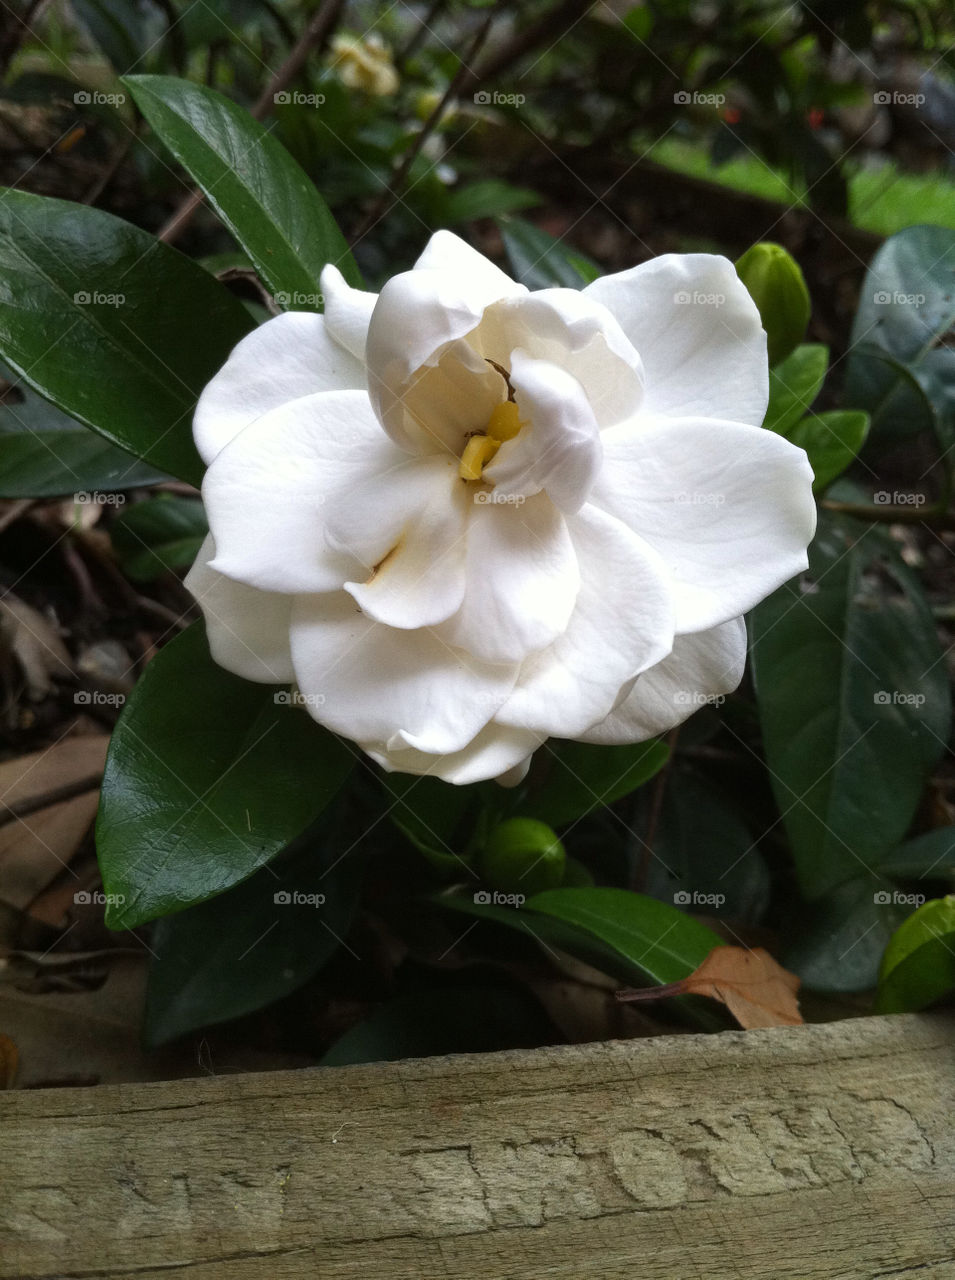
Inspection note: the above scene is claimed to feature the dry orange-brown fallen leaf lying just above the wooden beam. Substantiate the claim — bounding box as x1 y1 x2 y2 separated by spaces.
617 946 803 1030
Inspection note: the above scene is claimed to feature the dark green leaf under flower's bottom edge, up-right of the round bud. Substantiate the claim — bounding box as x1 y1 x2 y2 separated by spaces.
517 740 668 827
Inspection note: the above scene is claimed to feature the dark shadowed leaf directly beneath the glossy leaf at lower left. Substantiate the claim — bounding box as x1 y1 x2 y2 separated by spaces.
145 818 364 1044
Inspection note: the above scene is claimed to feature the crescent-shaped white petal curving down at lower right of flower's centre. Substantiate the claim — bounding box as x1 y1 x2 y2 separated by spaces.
495 504 673 737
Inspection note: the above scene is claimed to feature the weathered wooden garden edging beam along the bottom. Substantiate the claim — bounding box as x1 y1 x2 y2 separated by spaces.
0 1012 955 1280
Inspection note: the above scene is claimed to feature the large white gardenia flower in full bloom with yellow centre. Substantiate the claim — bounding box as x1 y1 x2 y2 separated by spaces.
187 232 815 783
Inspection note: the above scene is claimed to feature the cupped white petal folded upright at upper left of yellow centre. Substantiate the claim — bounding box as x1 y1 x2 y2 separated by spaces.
366 232 527 453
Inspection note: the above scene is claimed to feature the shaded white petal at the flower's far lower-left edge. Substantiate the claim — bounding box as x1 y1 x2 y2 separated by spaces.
186 534 293 685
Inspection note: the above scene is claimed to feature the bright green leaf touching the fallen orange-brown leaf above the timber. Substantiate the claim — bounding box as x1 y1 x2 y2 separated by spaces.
526 888 723 984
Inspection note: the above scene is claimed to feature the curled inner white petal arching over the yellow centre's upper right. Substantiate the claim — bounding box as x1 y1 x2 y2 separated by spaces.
472 289 644 428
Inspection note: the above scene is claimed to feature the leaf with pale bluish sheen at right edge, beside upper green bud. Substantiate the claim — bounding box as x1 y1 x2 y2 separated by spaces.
845 227 955 438
